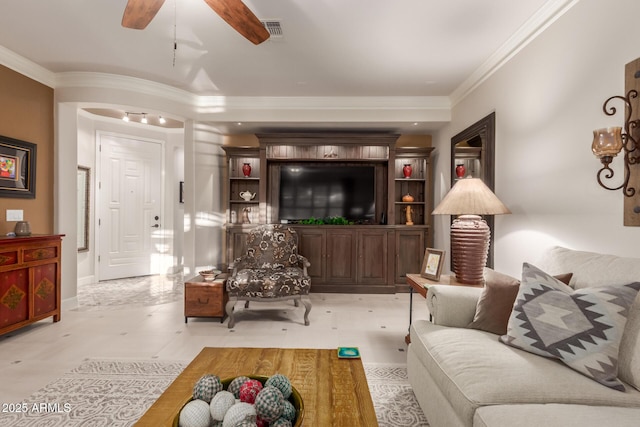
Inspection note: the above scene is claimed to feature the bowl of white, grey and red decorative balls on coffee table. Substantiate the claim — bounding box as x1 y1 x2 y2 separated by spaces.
173 374 304 427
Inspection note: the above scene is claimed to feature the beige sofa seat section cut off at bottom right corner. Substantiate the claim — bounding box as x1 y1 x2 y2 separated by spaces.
473 403 640 427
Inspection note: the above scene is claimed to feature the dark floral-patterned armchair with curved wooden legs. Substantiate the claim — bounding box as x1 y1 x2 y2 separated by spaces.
225 224 311 328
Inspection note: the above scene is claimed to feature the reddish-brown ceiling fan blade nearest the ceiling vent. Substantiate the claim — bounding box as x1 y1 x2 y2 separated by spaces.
204 0 269 44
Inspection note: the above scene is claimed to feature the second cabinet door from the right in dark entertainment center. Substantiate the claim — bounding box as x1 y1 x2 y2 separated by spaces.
356 230 389 285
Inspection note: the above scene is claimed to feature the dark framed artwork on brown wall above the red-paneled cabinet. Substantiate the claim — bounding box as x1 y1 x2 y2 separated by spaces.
0 136 37 199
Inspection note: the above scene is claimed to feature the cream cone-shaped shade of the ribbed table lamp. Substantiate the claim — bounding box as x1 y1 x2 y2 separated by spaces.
433 178 511 215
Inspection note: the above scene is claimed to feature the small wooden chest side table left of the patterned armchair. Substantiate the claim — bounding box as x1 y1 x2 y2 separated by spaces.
184 274 229 323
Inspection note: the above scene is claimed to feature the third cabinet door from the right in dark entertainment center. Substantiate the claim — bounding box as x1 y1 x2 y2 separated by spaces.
325 228 356 283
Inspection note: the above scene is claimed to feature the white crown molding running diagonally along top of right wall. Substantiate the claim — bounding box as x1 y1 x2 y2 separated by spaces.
450 0 580 107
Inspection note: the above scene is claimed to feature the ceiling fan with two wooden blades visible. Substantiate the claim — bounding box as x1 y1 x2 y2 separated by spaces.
122 0 269 44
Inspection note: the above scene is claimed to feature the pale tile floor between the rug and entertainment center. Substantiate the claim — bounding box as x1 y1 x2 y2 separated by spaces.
0 276 428 403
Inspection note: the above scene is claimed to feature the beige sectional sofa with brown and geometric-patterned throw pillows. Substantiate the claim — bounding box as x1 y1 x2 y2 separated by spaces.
407 247 640 427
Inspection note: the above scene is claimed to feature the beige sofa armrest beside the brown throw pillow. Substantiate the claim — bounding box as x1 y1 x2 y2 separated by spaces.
427 285 482 328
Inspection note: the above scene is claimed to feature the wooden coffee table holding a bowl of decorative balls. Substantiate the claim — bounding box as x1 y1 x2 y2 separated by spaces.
136 347 378 427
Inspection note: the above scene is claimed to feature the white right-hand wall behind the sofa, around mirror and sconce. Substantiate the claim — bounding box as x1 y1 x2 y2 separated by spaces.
434 0 640 277
